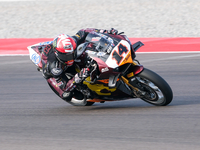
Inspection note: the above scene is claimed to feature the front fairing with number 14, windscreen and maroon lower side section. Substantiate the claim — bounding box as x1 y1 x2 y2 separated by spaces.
83 33 133 91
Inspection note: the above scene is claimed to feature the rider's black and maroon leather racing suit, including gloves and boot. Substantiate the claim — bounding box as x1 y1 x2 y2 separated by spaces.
42 28 118 101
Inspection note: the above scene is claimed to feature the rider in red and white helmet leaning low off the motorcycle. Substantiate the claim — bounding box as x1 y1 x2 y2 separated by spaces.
42 28 118 101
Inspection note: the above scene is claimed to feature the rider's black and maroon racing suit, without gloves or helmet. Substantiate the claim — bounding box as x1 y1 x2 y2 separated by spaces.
42 28 113 101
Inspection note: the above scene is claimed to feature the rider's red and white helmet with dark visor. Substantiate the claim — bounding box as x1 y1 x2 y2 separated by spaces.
53 34 76 66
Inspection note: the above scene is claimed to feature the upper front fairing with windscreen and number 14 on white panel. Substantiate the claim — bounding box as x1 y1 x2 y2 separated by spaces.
86 32 132 68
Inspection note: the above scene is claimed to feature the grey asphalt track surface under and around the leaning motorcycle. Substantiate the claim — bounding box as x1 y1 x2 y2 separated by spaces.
0 53 200 150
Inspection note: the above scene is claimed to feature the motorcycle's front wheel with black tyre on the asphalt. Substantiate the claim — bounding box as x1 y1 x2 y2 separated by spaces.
130 68 173 106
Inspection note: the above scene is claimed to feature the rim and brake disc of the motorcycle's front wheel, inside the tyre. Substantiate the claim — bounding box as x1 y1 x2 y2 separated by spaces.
136 77 166 104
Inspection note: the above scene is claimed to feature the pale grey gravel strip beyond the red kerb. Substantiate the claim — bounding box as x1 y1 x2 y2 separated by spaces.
0 0 200 38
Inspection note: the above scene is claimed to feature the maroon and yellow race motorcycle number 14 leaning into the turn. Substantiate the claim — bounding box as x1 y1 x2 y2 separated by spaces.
28 32 173 106
